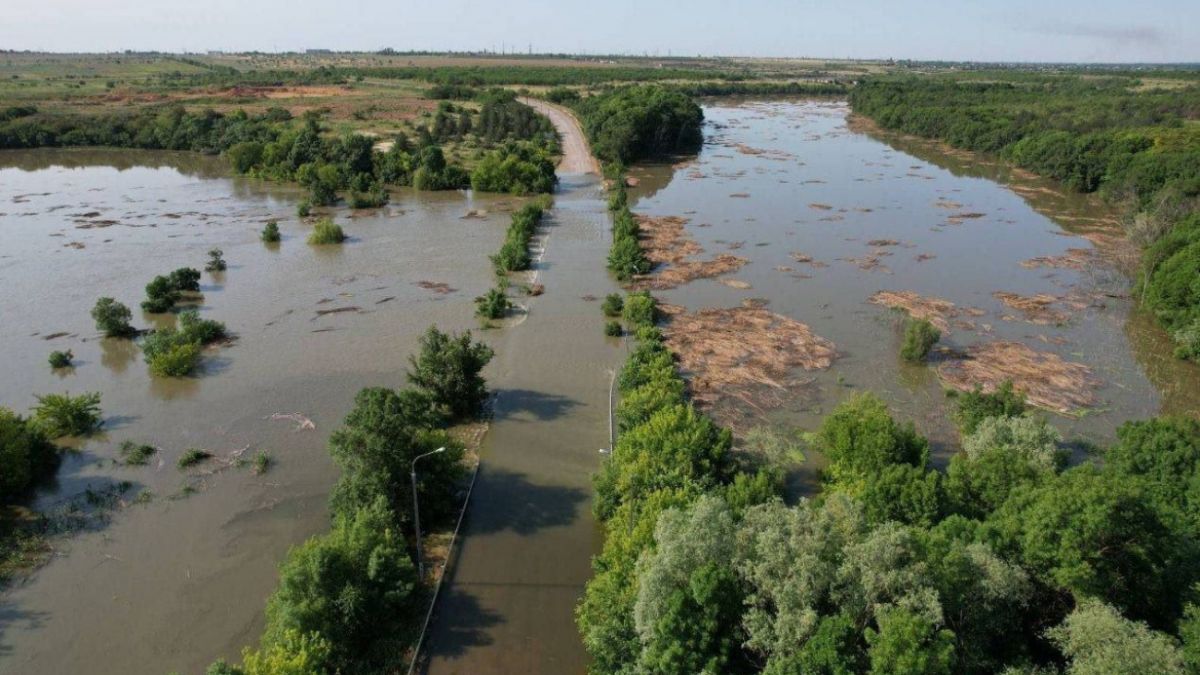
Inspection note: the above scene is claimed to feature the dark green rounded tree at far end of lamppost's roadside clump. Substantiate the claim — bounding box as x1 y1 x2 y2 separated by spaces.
408 327 494 419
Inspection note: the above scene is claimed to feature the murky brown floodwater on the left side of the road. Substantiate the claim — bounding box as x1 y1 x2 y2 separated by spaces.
0 150 518 674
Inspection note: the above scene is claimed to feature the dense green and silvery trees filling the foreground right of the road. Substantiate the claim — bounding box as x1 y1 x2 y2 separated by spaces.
577 293 1200 675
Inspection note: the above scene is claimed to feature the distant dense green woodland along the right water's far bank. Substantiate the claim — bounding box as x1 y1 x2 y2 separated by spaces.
850 73 1200 358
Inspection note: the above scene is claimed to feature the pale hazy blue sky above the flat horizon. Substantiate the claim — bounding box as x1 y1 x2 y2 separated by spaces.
0 0 1200 62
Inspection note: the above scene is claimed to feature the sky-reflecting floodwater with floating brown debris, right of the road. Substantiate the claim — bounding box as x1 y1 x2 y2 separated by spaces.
631 102 1200 464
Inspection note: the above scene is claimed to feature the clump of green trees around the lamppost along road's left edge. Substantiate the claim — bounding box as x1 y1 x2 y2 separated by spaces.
208 327 493 675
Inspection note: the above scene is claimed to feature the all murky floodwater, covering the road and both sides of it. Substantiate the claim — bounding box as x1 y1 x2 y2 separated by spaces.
0 97 1200 673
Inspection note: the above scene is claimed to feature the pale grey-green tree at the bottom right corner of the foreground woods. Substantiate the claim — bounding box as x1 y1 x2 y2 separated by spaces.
1046 599 1187 675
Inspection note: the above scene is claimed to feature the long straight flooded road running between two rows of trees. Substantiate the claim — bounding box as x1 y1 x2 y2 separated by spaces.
422 102 624 675
